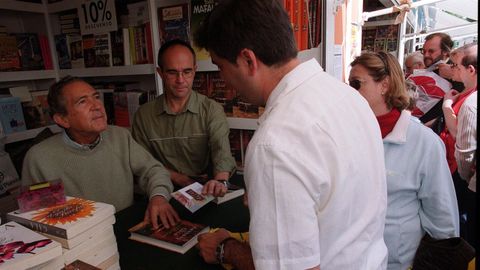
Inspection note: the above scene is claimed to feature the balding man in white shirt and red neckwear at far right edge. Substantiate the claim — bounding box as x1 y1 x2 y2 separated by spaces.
443 43 478 248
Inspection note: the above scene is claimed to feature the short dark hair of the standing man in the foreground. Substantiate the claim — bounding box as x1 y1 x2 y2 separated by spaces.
194 0 297 66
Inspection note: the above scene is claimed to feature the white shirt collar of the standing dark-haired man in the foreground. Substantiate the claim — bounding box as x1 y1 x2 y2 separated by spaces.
258 59 323 124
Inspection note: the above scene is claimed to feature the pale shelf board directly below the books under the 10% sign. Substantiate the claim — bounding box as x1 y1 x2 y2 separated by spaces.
59 64 155 77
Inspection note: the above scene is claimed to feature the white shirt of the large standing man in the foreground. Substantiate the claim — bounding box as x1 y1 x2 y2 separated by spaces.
245 60 387 270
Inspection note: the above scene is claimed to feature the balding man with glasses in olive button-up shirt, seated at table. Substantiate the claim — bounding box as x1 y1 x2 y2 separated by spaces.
132 40 235 200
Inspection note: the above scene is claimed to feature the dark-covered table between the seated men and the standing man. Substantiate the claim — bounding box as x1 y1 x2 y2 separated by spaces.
114 180 250 270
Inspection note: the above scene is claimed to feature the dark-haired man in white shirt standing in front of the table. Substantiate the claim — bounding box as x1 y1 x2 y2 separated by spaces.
195 0 387 270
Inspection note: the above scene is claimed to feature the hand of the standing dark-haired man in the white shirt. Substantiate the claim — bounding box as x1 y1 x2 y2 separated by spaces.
197 229 230 263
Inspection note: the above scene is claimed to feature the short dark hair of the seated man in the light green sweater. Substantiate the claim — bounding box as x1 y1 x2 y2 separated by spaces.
47 75 86 117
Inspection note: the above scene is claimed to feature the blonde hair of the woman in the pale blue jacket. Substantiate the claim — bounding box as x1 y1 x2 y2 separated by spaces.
350 51 412 111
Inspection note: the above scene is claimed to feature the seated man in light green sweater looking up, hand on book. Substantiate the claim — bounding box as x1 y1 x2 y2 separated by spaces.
22 76 179 228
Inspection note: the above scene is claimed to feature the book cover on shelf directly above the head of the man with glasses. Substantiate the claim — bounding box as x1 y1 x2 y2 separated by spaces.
158 3 190 44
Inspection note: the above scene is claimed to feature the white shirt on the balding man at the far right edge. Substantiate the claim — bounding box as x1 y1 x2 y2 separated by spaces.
455 91 477 192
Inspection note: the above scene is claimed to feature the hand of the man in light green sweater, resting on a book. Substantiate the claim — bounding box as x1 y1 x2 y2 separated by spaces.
144 195 180 229
